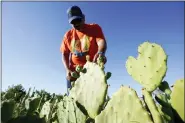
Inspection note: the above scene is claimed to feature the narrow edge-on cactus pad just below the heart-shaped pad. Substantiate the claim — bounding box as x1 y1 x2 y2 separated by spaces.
142 88 163 123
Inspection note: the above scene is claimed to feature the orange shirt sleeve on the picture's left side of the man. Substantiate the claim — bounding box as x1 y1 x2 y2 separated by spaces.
60 33 70 53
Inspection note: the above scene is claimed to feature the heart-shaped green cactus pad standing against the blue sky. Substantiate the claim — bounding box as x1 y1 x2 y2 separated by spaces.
126 42 167 92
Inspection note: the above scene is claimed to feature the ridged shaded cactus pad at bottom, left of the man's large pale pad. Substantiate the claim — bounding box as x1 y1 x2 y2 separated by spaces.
57 96 86 123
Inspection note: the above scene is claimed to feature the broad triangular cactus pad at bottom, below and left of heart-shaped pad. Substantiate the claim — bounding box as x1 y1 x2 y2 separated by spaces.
95 86 153 123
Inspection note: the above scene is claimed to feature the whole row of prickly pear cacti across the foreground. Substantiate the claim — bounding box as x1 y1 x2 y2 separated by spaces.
1 42 184 123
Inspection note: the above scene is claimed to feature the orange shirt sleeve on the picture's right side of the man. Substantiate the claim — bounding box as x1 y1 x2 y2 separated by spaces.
95 24 105 42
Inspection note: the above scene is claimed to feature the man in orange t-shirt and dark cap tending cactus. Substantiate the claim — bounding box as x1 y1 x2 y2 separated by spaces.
60 6 107 93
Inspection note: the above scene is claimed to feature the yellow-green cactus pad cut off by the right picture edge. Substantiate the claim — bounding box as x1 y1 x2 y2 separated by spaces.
170 79 185 121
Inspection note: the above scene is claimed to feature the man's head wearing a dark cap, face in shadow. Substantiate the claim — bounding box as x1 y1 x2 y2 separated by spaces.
67 6 85 30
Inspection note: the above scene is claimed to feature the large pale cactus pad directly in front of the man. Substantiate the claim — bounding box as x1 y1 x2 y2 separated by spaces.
70 61 108 119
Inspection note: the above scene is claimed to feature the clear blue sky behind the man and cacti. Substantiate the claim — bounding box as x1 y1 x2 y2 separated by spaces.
2 2 184 95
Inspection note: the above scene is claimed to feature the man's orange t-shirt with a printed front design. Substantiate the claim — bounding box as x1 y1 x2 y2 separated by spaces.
60 24 105 67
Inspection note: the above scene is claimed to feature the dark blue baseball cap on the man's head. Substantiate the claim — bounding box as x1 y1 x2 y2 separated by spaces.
67 6 83 23
